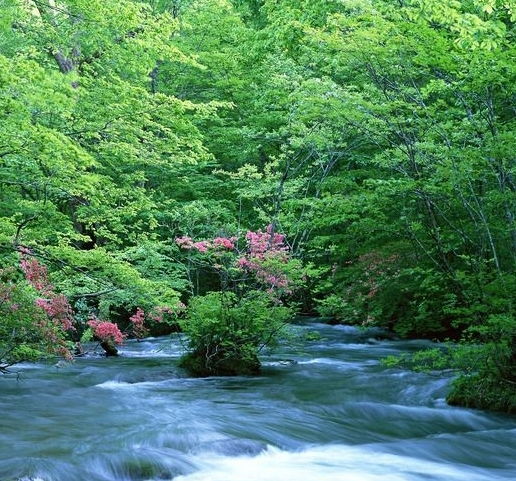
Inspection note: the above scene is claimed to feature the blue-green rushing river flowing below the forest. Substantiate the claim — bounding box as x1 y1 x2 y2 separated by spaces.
0 323 516 481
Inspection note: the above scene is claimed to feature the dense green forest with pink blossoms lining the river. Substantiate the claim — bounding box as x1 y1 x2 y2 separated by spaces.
0 0 516 412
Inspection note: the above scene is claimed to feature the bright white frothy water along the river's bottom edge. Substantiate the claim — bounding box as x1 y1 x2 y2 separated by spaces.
174 445 506 481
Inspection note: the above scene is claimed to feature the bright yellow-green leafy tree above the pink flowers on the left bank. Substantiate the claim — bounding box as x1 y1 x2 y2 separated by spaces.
0 0 215 317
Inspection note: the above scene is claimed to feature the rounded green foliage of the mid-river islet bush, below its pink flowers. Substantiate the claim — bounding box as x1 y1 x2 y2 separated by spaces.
180 291 293 376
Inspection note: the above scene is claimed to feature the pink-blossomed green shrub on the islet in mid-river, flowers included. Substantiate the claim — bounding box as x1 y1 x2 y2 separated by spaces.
176 225 304 376
